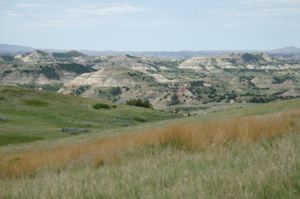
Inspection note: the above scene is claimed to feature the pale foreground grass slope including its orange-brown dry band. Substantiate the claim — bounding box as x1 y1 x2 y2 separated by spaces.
0 85 300 198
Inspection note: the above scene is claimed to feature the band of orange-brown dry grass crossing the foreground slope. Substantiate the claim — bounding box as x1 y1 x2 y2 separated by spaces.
0 110 300 177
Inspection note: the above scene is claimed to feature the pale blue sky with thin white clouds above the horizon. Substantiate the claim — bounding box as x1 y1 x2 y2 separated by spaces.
0 0 300 51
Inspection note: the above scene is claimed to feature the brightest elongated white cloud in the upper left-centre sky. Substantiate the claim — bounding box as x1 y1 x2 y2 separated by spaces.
66 6 146 16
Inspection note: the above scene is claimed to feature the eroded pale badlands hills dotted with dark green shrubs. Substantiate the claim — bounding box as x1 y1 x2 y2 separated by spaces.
0 50 300 113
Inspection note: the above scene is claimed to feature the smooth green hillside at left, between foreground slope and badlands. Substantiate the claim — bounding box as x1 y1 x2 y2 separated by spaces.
0 85 176 146
